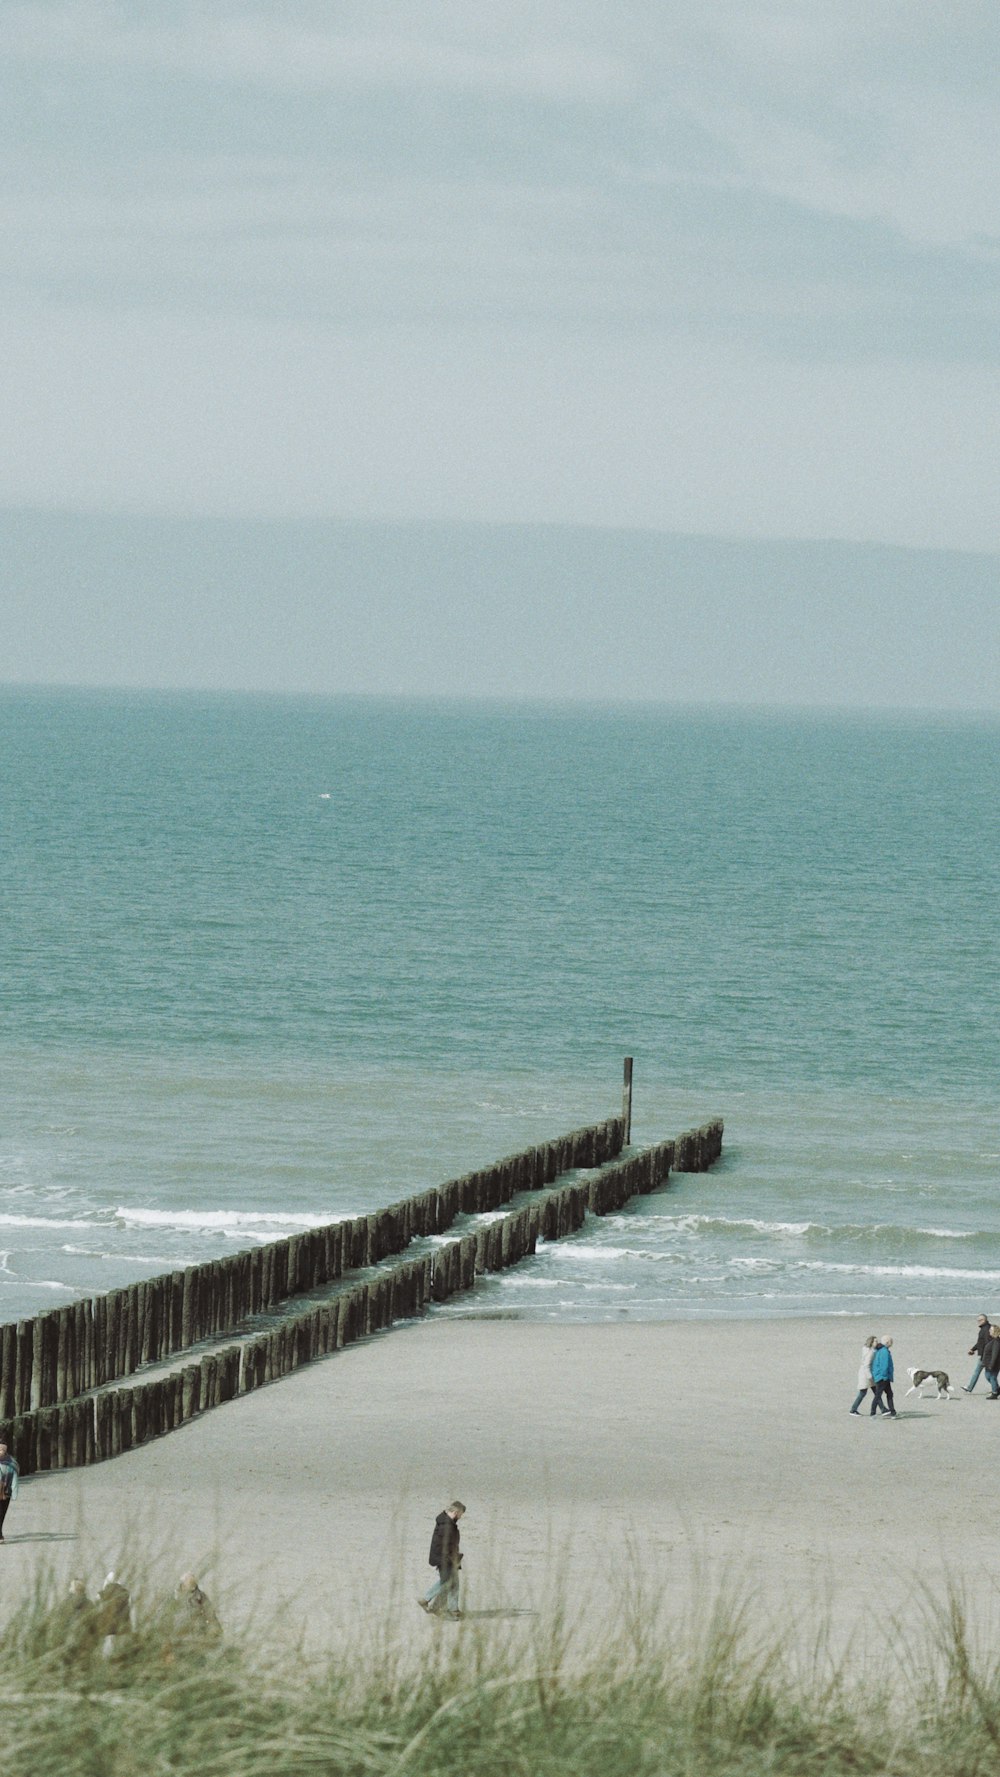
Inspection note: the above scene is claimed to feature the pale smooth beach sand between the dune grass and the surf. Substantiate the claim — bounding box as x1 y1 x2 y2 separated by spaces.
0 1313 1000 1649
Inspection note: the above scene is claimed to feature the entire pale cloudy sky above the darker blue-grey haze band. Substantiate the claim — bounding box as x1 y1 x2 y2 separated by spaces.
0 0 1000 702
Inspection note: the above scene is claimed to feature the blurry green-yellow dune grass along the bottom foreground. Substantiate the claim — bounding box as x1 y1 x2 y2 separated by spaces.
0 1578 1000 1777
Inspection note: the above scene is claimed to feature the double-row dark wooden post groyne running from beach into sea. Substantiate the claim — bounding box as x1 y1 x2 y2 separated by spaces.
0 1118 723 1475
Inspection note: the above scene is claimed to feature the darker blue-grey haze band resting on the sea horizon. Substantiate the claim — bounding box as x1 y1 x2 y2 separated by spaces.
0 510 1000 713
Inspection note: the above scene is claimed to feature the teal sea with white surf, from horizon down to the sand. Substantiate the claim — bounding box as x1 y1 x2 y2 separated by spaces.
0 689 1000 1320
